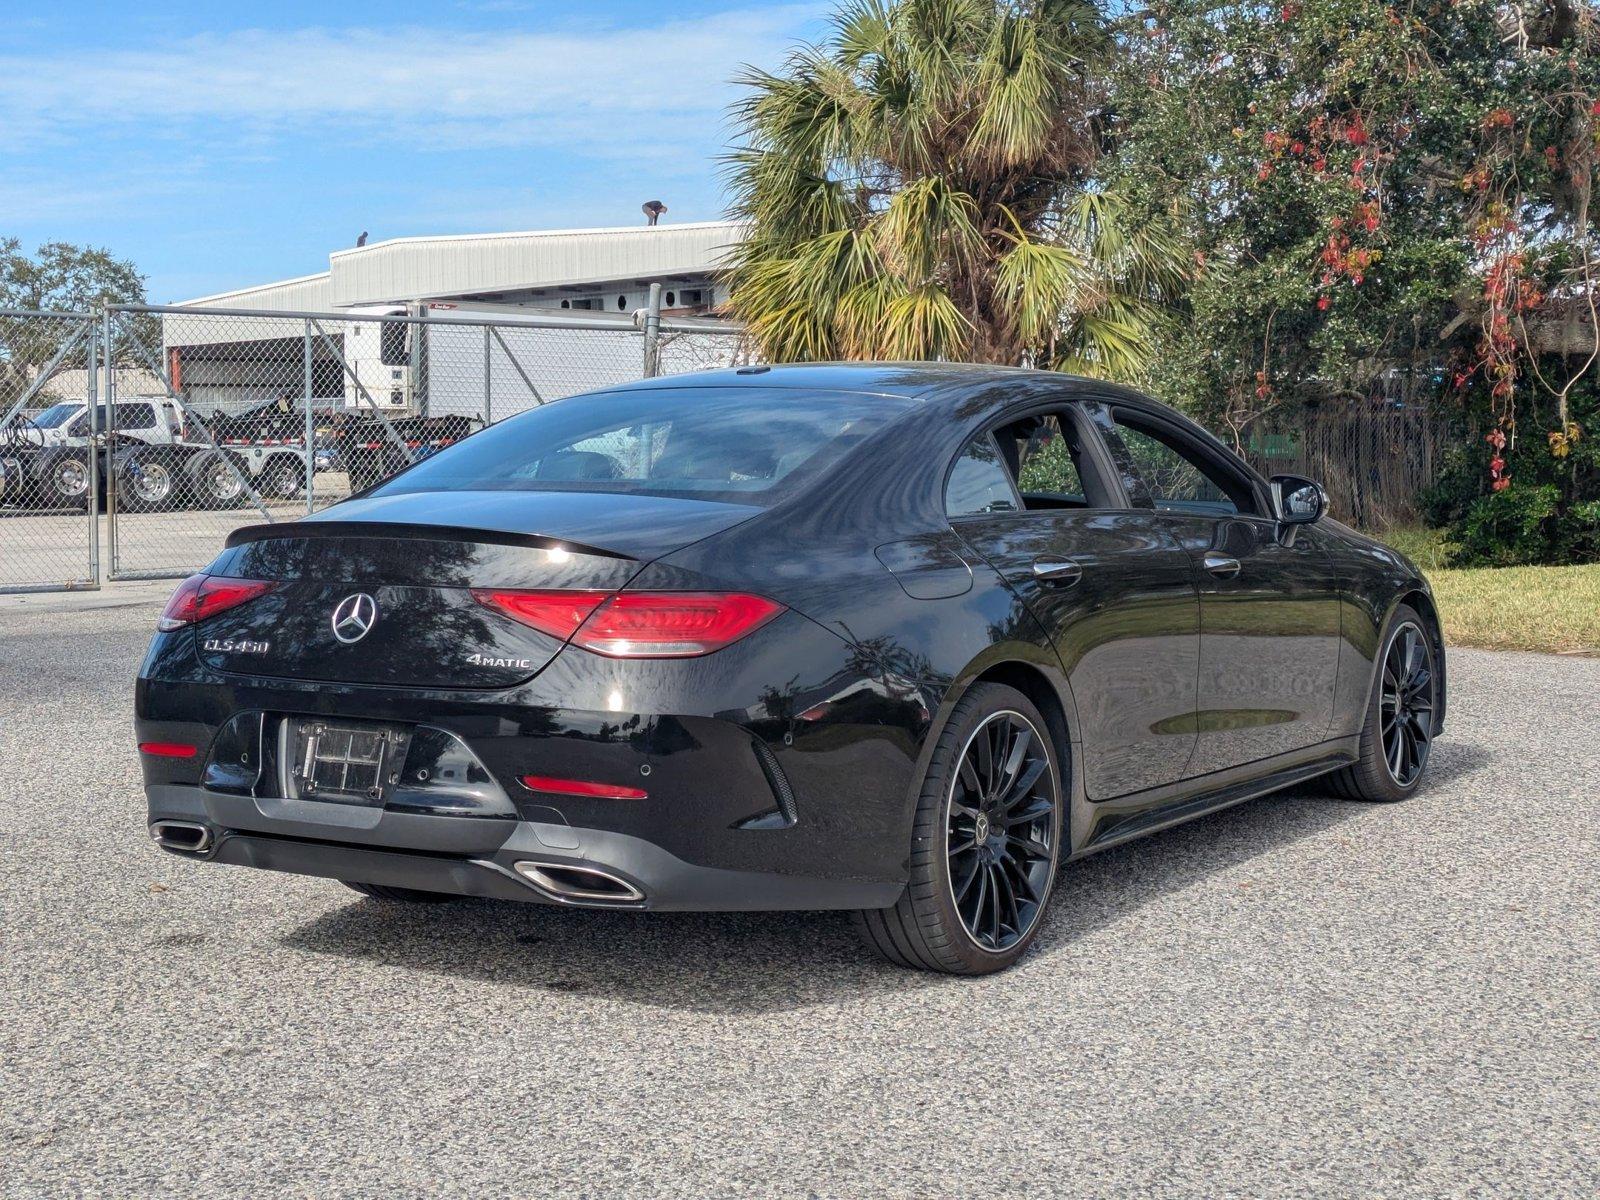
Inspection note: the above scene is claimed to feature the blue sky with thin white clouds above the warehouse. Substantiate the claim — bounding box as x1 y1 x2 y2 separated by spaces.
0 0 827 302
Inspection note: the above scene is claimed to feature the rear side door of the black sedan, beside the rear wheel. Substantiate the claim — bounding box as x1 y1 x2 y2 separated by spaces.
946 405 1200 800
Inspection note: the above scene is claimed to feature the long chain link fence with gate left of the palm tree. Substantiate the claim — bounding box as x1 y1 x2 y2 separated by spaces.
0 306 752 590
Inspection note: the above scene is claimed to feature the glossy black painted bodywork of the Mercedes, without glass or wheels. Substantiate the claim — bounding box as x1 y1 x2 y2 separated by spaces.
136 366 1443 907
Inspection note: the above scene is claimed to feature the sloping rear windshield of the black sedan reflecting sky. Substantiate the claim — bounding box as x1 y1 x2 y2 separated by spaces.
371 387 914 506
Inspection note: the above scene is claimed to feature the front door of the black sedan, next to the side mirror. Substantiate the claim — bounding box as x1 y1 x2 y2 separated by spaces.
1091 403 1339 776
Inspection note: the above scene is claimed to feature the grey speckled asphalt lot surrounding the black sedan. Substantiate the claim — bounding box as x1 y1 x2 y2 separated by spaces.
0 587 1600 1197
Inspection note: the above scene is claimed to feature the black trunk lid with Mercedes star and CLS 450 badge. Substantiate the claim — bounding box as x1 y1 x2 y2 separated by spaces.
194 493 758 690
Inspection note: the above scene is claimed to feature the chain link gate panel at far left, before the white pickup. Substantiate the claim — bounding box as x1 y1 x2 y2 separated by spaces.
0 309 104 592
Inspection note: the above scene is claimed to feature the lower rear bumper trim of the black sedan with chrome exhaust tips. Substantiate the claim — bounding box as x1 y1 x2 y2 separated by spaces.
146 784 904 910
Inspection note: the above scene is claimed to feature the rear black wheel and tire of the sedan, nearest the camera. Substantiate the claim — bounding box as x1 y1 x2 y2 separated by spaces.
854 683 1066 974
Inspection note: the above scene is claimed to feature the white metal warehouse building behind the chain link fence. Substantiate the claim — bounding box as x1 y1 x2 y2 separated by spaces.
162 221 755 413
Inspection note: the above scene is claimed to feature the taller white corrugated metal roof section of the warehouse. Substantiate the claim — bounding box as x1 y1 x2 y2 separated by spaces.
328 221 742 307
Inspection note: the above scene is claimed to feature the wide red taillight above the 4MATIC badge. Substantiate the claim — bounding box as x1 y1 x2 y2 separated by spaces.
472 587 784 658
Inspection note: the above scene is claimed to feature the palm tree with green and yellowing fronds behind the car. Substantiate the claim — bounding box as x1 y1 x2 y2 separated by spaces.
728 0 1181 376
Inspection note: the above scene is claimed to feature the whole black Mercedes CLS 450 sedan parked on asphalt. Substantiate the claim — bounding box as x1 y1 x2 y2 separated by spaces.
136 365 1445 973
